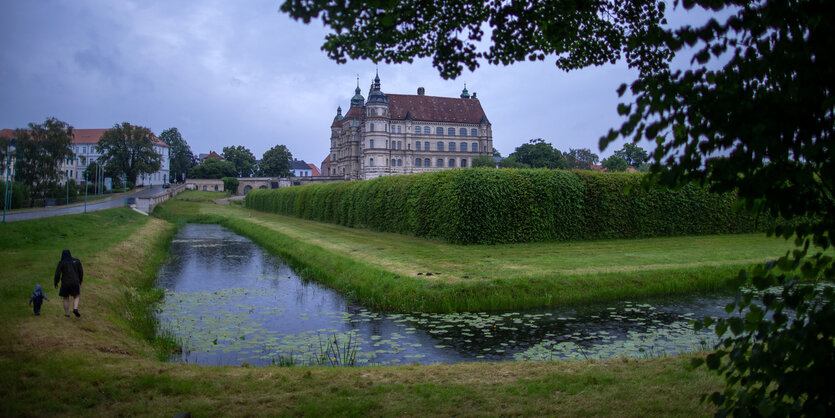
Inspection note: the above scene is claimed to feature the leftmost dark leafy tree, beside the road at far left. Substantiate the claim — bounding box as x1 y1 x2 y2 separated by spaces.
14 118 73 199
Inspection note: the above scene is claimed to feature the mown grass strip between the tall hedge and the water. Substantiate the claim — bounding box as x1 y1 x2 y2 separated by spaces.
156 201 792 312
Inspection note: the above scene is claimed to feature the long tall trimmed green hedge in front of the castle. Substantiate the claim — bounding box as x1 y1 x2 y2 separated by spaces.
246 169 763 244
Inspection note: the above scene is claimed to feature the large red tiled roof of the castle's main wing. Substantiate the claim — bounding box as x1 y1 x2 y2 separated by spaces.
386 94 486 123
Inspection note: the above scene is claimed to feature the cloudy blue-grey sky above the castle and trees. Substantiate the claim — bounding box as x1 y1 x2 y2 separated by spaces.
0 0 720 166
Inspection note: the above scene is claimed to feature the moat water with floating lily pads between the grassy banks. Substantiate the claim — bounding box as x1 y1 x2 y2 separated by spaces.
157 224 732 365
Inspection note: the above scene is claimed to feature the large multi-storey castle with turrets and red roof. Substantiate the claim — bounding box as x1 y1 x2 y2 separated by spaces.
322 74 493 180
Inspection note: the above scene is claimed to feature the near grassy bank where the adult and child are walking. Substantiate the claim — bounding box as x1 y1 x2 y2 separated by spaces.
0 209 721 417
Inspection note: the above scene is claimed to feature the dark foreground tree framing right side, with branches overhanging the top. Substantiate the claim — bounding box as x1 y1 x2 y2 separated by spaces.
282 0 835 415
